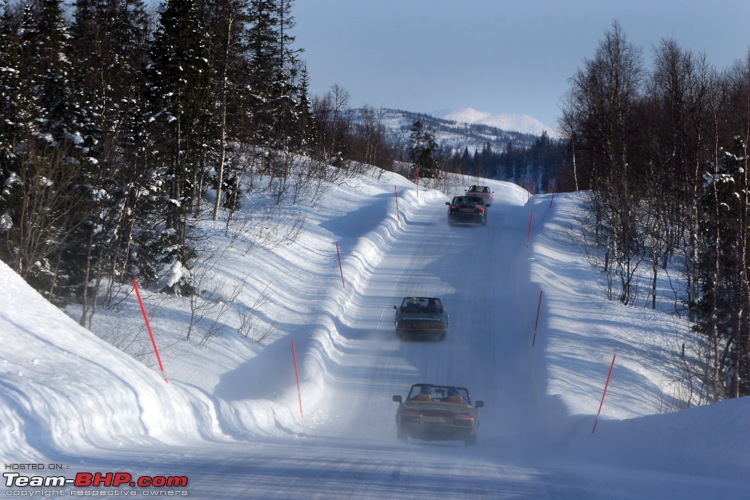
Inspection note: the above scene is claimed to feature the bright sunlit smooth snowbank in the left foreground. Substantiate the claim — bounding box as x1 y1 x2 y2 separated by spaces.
0 262 234 462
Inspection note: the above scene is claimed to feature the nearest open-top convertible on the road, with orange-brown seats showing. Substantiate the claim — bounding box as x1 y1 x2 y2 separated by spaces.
393 384 484 446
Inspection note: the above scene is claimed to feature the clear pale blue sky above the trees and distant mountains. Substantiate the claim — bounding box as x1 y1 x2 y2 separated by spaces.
292 0 750 126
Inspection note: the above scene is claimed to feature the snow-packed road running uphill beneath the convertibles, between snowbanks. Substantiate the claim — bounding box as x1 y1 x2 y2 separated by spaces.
69 190 581 498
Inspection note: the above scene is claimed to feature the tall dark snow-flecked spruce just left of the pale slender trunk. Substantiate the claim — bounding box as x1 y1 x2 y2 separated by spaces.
148 0 211 291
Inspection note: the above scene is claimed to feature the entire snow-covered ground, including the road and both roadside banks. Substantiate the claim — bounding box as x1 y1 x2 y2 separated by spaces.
0 166 750 499
